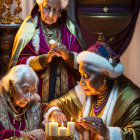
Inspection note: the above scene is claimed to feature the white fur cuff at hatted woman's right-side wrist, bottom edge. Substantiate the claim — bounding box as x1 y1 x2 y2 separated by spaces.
108 127 122 140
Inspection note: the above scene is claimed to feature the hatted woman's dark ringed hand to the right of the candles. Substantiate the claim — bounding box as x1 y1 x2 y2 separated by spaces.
78 117 108 137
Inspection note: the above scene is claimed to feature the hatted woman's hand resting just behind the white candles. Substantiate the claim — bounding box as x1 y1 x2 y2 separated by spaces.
49 110 67 126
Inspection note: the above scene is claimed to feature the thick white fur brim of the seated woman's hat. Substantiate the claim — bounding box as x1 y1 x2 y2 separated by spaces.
77 51 124 78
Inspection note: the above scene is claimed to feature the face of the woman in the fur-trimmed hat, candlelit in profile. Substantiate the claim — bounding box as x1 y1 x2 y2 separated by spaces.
79 63 105 95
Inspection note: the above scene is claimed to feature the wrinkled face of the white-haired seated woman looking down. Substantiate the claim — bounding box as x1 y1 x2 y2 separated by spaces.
13 74 36 107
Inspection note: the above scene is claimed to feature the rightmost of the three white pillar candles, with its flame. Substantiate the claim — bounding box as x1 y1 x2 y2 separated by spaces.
67 118 75 136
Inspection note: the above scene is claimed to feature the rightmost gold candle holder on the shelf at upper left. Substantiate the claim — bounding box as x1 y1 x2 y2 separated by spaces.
13 0 23 24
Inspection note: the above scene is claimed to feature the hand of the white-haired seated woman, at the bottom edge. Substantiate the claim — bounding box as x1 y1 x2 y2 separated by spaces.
20 129 45 140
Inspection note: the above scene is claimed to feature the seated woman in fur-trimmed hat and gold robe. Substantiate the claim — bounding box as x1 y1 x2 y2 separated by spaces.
46 43 140 140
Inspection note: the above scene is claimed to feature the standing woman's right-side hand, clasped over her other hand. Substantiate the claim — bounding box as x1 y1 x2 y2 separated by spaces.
51 42 69 60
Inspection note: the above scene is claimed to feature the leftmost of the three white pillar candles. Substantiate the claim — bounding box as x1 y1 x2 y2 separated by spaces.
49 121 58 136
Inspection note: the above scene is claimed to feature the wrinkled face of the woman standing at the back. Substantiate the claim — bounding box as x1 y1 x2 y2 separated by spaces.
39 0 61 25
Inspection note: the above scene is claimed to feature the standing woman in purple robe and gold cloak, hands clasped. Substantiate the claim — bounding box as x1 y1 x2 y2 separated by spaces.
10 0 85 102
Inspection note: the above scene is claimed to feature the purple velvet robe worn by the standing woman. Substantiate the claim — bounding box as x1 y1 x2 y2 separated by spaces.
17 22 82 99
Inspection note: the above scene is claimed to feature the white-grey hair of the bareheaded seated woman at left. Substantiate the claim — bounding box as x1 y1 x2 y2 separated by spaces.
0 64 39 92
